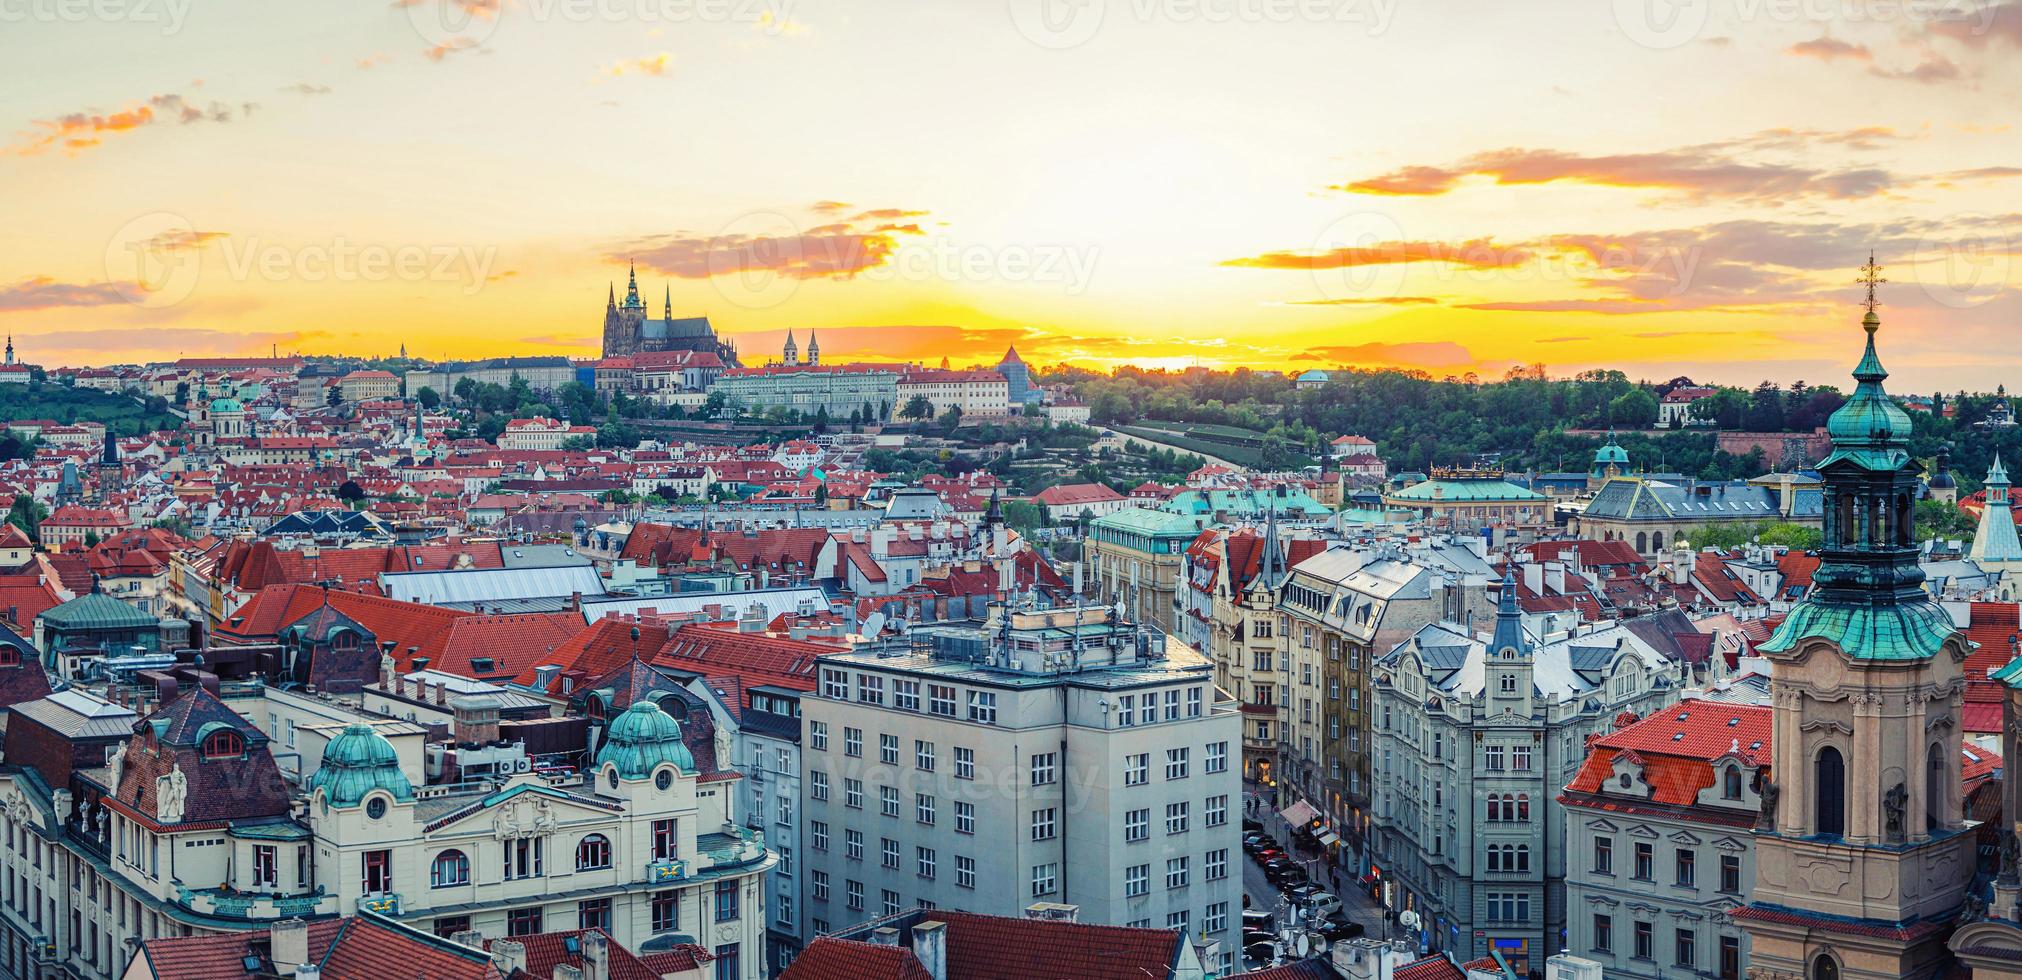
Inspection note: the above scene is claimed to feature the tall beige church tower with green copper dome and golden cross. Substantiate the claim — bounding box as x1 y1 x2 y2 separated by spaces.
1731 259 1975 980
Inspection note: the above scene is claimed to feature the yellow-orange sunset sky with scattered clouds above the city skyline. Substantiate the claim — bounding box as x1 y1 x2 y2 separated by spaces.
0 0 2022 392
